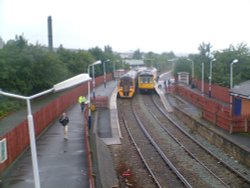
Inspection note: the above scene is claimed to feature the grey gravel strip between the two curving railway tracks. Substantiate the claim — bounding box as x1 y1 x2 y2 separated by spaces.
136 95 225 187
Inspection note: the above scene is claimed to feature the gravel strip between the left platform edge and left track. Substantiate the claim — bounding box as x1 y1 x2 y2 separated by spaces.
110 99 157 188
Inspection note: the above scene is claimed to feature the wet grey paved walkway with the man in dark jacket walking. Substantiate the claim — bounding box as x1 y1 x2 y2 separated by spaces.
0 100 89 188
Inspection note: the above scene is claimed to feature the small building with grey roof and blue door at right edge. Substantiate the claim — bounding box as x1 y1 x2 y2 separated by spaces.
229 80 250 116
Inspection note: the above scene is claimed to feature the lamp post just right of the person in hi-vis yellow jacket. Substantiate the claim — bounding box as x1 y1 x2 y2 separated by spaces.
88 60 102 128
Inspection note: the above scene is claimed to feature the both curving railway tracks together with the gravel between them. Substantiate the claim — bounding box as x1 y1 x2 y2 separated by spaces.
118 95 250 187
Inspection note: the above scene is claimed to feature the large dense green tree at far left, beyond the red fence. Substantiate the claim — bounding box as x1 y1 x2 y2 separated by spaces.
0 37 68 95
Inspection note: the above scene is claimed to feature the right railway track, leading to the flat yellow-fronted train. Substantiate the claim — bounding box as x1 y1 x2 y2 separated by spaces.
147 93 250 187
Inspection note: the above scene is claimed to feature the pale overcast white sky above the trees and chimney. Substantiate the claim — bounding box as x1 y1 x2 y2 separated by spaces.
0 0 250 54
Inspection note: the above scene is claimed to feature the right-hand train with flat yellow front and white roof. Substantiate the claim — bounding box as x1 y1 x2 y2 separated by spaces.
138 67 157 93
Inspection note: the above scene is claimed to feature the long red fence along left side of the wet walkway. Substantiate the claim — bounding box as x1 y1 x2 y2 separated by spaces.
0 74 113 178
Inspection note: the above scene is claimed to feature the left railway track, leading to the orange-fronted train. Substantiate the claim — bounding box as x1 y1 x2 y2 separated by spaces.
119 98 190 187
